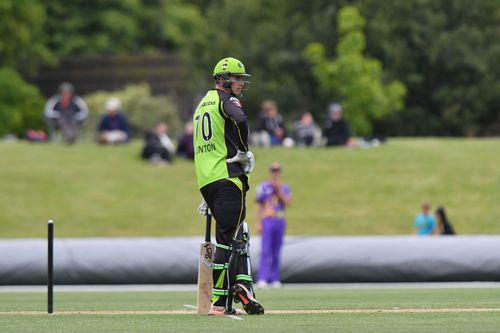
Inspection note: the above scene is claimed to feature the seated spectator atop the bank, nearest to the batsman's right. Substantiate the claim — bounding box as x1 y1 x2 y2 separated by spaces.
252 100 285 147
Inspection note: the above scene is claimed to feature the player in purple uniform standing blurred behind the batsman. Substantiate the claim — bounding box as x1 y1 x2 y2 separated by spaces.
256 162 291 287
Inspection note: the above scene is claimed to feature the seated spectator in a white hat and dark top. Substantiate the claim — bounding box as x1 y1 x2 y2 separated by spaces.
97 97 130 144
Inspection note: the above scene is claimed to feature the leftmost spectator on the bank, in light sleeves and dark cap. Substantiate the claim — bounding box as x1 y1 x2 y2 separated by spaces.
44 82 89 144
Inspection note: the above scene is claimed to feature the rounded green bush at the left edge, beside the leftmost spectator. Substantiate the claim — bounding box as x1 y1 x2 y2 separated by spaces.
0 67 44 136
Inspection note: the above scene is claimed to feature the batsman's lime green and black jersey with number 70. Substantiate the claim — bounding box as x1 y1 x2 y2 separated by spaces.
193 89 248 188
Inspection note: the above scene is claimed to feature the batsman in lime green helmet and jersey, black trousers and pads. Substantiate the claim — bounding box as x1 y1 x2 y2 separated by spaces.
193 58 264 315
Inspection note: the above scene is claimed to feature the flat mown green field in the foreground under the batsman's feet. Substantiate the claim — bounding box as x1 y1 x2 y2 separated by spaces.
0 288 500 333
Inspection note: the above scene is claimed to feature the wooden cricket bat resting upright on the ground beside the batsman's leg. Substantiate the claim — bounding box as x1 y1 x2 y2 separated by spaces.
197 212 215 315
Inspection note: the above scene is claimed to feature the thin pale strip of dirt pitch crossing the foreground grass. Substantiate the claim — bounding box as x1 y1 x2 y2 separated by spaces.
0 308 500 316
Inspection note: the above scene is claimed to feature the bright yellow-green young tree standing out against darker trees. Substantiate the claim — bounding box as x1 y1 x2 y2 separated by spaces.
305 6 406 135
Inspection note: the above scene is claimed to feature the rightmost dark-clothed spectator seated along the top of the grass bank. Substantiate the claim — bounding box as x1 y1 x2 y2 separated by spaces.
323 104 352 146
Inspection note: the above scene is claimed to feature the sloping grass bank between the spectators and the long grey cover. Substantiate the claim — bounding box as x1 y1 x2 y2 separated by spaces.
0 139 500 238
